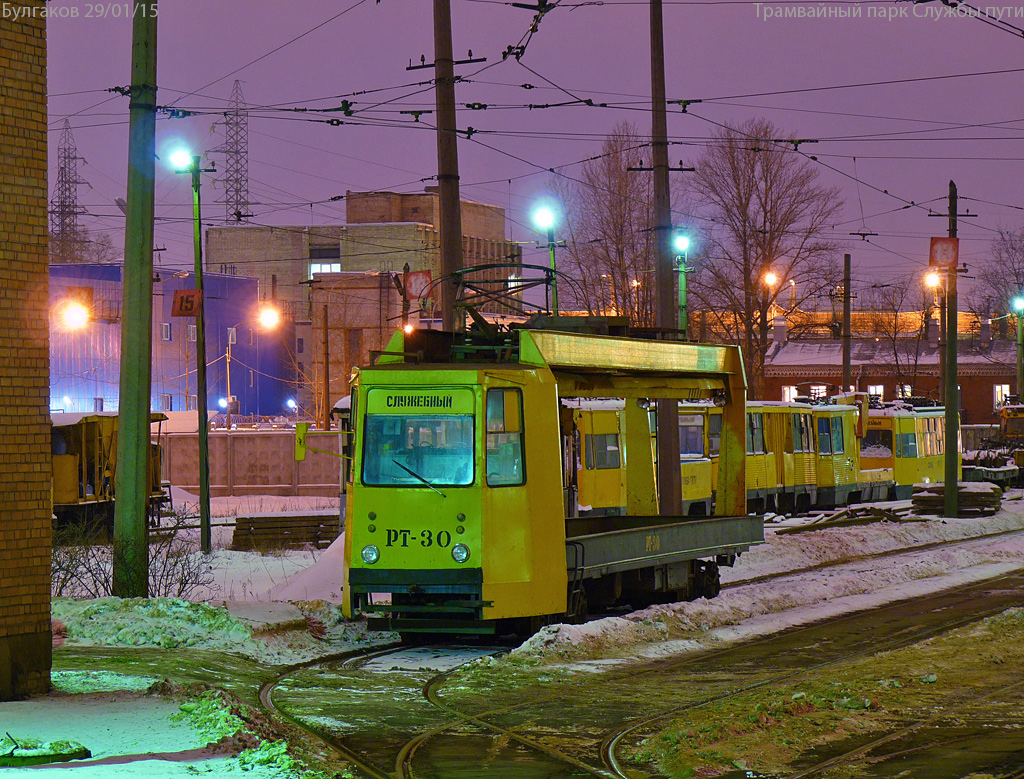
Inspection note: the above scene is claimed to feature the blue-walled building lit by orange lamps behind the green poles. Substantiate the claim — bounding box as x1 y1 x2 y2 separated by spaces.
50 263 296 417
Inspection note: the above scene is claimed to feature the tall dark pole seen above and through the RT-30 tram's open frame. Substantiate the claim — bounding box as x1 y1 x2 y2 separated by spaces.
650 0 684 516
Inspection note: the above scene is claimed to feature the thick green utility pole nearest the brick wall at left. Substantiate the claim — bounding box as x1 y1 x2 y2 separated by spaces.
113 3 157 598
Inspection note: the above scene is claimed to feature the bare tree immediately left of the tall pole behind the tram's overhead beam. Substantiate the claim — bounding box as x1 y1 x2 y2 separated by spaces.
555 122 656 326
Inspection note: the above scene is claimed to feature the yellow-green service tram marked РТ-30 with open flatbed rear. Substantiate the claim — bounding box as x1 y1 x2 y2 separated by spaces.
343 329 764 634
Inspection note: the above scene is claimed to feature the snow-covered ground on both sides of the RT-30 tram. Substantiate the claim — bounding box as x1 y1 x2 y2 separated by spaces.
12 490 1024 779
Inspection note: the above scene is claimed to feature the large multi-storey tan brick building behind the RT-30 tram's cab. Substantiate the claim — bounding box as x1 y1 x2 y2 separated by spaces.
206 187 522 416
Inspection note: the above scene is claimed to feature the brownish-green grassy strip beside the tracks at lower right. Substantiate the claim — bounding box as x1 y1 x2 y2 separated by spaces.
628 609 1024 777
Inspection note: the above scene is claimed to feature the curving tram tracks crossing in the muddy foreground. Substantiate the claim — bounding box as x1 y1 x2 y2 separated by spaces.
260 531 1024 779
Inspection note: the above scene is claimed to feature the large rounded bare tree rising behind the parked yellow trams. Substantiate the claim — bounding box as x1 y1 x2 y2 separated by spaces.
688 119 842 397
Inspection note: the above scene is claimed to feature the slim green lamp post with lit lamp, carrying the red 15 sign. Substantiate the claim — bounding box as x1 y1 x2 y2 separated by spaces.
171 149 215 555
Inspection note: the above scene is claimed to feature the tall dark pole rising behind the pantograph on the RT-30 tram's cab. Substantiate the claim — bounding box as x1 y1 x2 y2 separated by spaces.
434 0 462 332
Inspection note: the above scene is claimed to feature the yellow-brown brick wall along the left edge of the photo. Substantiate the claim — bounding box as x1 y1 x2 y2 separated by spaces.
0 13 51 700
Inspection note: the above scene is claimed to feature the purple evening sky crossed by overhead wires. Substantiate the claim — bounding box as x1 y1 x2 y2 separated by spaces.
48 0 1024 303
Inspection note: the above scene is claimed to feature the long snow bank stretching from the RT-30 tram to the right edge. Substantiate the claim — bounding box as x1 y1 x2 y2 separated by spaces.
510 504 1024 662
